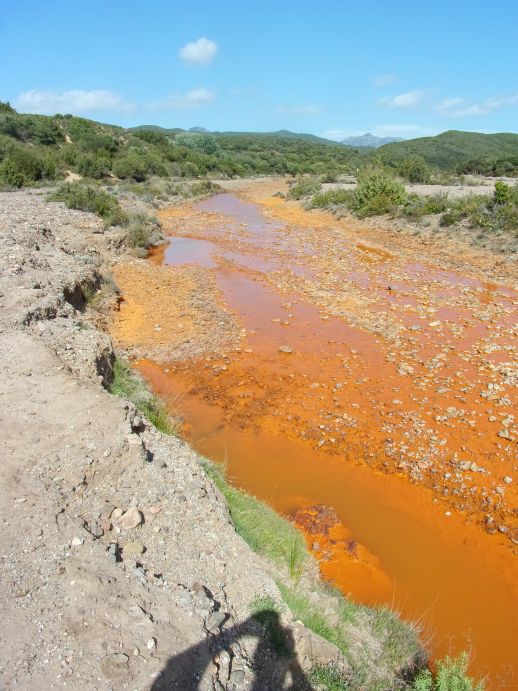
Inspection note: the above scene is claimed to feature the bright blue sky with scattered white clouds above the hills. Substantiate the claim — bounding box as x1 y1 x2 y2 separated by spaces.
0 0 518 139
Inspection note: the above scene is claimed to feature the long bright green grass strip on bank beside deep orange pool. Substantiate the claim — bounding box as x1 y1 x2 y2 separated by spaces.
204 460 309 581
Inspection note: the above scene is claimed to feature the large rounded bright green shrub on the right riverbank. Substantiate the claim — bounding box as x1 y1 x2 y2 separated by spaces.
352 165 407 216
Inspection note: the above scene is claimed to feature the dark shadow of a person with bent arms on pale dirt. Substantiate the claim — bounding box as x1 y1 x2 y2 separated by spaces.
151 610 314 691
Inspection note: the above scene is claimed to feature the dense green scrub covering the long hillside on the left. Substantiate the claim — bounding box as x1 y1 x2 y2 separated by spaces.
0 103 364 187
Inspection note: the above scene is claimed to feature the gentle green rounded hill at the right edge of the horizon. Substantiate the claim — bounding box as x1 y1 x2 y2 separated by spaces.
377 130 518 170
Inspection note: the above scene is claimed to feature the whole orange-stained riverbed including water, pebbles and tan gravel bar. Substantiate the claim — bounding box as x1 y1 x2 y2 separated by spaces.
112 181 518 688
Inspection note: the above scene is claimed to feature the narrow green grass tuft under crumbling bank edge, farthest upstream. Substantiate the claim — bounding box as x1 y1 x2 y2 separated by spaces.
108 358 177 434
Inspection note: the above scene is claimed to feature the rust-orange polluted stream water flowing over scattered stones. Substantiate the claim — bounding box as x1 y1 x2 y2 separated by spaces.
121 195 518 689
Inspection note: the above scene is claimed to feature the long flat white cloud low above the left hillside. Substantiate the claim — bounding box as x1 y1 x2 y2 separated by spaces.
16 89 133 115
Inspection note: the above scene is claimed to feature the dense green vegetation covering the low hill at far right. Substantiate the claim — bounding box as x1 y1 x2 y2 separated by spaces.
376 130 518 175
